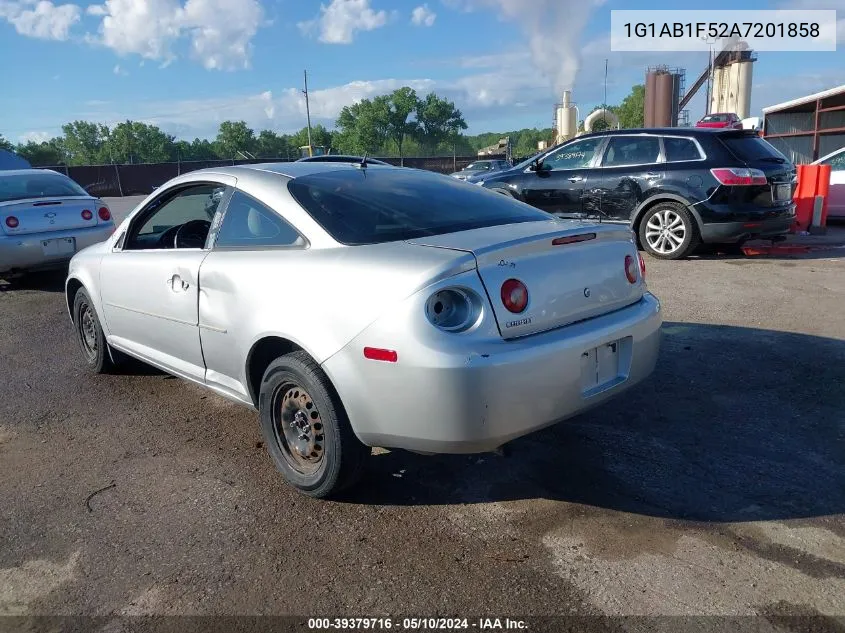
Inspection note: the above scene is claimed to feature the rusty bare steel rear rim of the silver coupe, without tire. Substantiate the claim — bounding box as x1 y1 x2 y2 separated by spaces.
272 383 325 475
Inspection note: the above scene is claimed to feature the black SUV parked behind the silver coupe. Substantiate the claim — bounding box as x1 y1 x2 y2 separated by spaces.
475 128 796 259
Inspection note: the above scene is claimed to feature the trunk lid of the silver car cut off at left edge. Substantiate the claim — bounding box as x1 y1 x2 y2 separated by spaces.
0 196 104 235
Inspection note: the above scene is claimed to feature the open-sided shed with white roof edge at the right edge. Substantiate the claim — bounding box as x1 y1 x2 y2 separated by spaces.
763 85 845 164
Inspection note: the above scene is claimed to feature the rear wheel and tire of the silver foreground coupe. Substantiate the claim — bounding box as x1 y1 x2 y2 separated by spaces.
258 351 371 498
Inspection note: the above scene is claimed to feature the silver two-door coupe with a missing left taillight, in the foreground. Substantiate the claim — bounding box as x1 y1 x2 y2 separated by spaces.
66 161 662 497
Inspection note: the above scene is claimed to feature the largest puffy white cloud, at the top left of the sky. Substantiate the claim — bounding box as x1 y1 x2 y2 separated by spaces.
87 0 264 70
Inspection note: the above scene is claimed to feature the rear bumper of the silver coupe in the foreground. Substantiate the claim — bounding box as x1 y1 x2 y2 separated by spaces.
323 293 662 453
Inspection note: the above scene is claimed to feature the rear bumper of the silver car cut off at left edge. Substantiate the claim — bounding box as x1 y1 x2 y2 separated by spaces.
0 222 115 273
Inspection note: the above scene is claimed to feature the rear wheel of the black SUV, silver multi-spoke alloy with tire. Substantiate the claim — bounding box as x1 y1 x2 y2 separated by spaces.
638 202 701 259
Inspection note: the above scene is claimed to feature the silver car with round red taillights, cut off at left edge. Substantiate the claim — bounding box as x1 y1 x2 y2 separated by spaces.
0 169 115 277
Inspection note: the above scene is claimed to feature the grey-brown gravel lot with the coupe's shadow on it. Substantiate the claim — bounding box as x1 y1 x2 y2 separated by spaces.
0 200 845 630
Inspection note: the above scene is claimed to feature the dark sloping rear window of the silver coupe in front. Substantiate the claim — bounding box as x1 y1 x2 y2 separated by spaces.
288 168 552 245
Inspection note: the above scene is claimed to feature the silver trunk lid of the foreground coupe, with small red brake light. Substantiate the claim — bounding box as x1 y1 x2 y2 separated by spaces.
409 221 645 339
